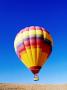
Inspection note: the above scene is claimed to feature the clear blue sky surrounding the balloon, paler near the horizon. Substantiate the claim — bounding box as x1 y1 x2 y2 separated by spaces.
0 0 67 84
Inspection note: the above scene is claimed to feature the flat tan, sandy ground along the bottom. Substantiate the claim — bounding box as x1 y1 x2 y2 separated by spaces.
0 83 67 90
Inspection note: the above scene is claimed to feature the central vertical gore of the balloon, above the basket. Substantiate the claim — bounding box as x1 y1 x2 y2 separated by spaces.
29 28 37 66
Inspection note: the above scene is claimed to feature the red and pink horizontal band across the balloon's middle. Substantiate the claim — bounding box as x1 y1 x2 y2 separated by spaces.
17 38 51 52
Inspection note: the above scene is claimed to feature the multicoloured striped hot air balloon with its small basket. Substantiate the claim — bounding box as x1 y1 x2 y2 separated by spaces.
14 26 53 81
